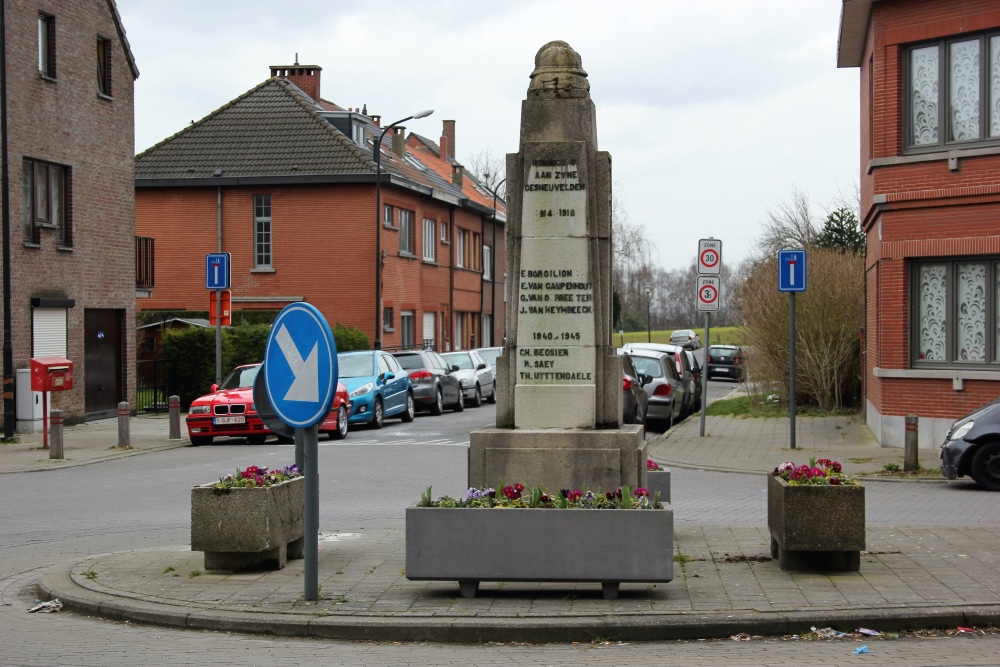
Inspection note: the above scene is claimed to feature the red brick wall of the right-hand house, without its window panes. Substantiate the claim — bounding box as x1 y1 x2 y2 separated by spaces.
838 0 1000 447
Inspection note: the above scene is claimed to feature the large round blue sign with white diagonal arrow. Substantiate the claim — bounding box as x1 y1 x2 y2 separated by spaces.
264 303 340 428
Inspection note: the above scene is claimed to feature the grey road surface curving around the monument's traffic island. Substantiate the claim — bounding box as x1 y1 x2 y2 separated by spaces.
0 402 1000 667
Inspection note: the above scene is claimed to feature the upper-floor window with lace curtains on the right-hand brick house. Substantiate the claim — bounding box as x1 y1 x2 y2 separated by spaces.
903 33 1000 152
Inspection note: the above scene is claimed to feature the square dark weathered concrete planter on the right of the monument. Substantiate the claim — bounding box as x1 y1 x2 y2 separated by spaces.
767 473 865 572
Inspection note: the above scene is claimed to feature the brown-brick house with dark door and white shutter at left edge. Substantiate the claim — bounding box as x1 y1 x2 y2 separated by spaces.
4 0 139 429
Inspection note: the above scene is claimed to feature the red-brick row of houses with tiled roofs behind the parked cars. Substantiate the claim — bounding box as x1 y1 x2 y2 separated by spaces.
135 64 505 350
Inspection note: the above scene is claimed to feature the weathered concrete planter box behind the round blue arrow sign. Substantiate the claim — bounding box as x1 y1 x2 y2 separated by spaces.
191 477 306 570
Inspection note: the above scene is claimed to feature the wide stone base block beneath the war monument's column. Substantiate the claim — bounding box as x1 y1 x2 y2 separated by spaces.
469 424 646 494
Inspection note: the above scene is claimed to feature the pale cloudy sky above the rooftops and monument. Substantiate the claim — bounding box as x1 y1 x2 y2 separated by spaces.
118 0 859 269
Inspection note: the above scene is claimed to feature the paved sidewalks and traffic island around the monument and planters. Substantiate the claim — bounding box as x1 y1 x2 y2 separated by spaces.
7 404 1000 643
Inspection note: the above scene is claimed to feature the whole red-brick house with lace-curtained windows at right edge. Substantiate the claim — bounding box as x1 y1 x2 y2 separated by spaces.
837 0 1000 447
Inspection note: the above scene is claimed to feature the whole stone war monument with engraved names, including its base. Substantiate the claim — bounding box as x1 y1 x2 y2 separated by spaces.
469 41 646 493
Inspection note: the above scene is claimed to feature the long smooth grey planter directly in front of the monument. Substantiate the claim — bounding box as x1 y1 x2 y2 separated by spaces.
406 503 674 599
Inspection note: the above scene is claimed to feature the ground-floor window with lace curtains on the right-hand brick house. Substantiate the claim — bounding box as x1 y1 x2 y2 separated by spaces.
911 257 1000 367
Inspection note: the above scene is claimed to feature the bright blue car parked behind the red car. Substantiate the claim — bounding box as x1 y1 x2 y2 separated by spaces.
337 350 415 428
